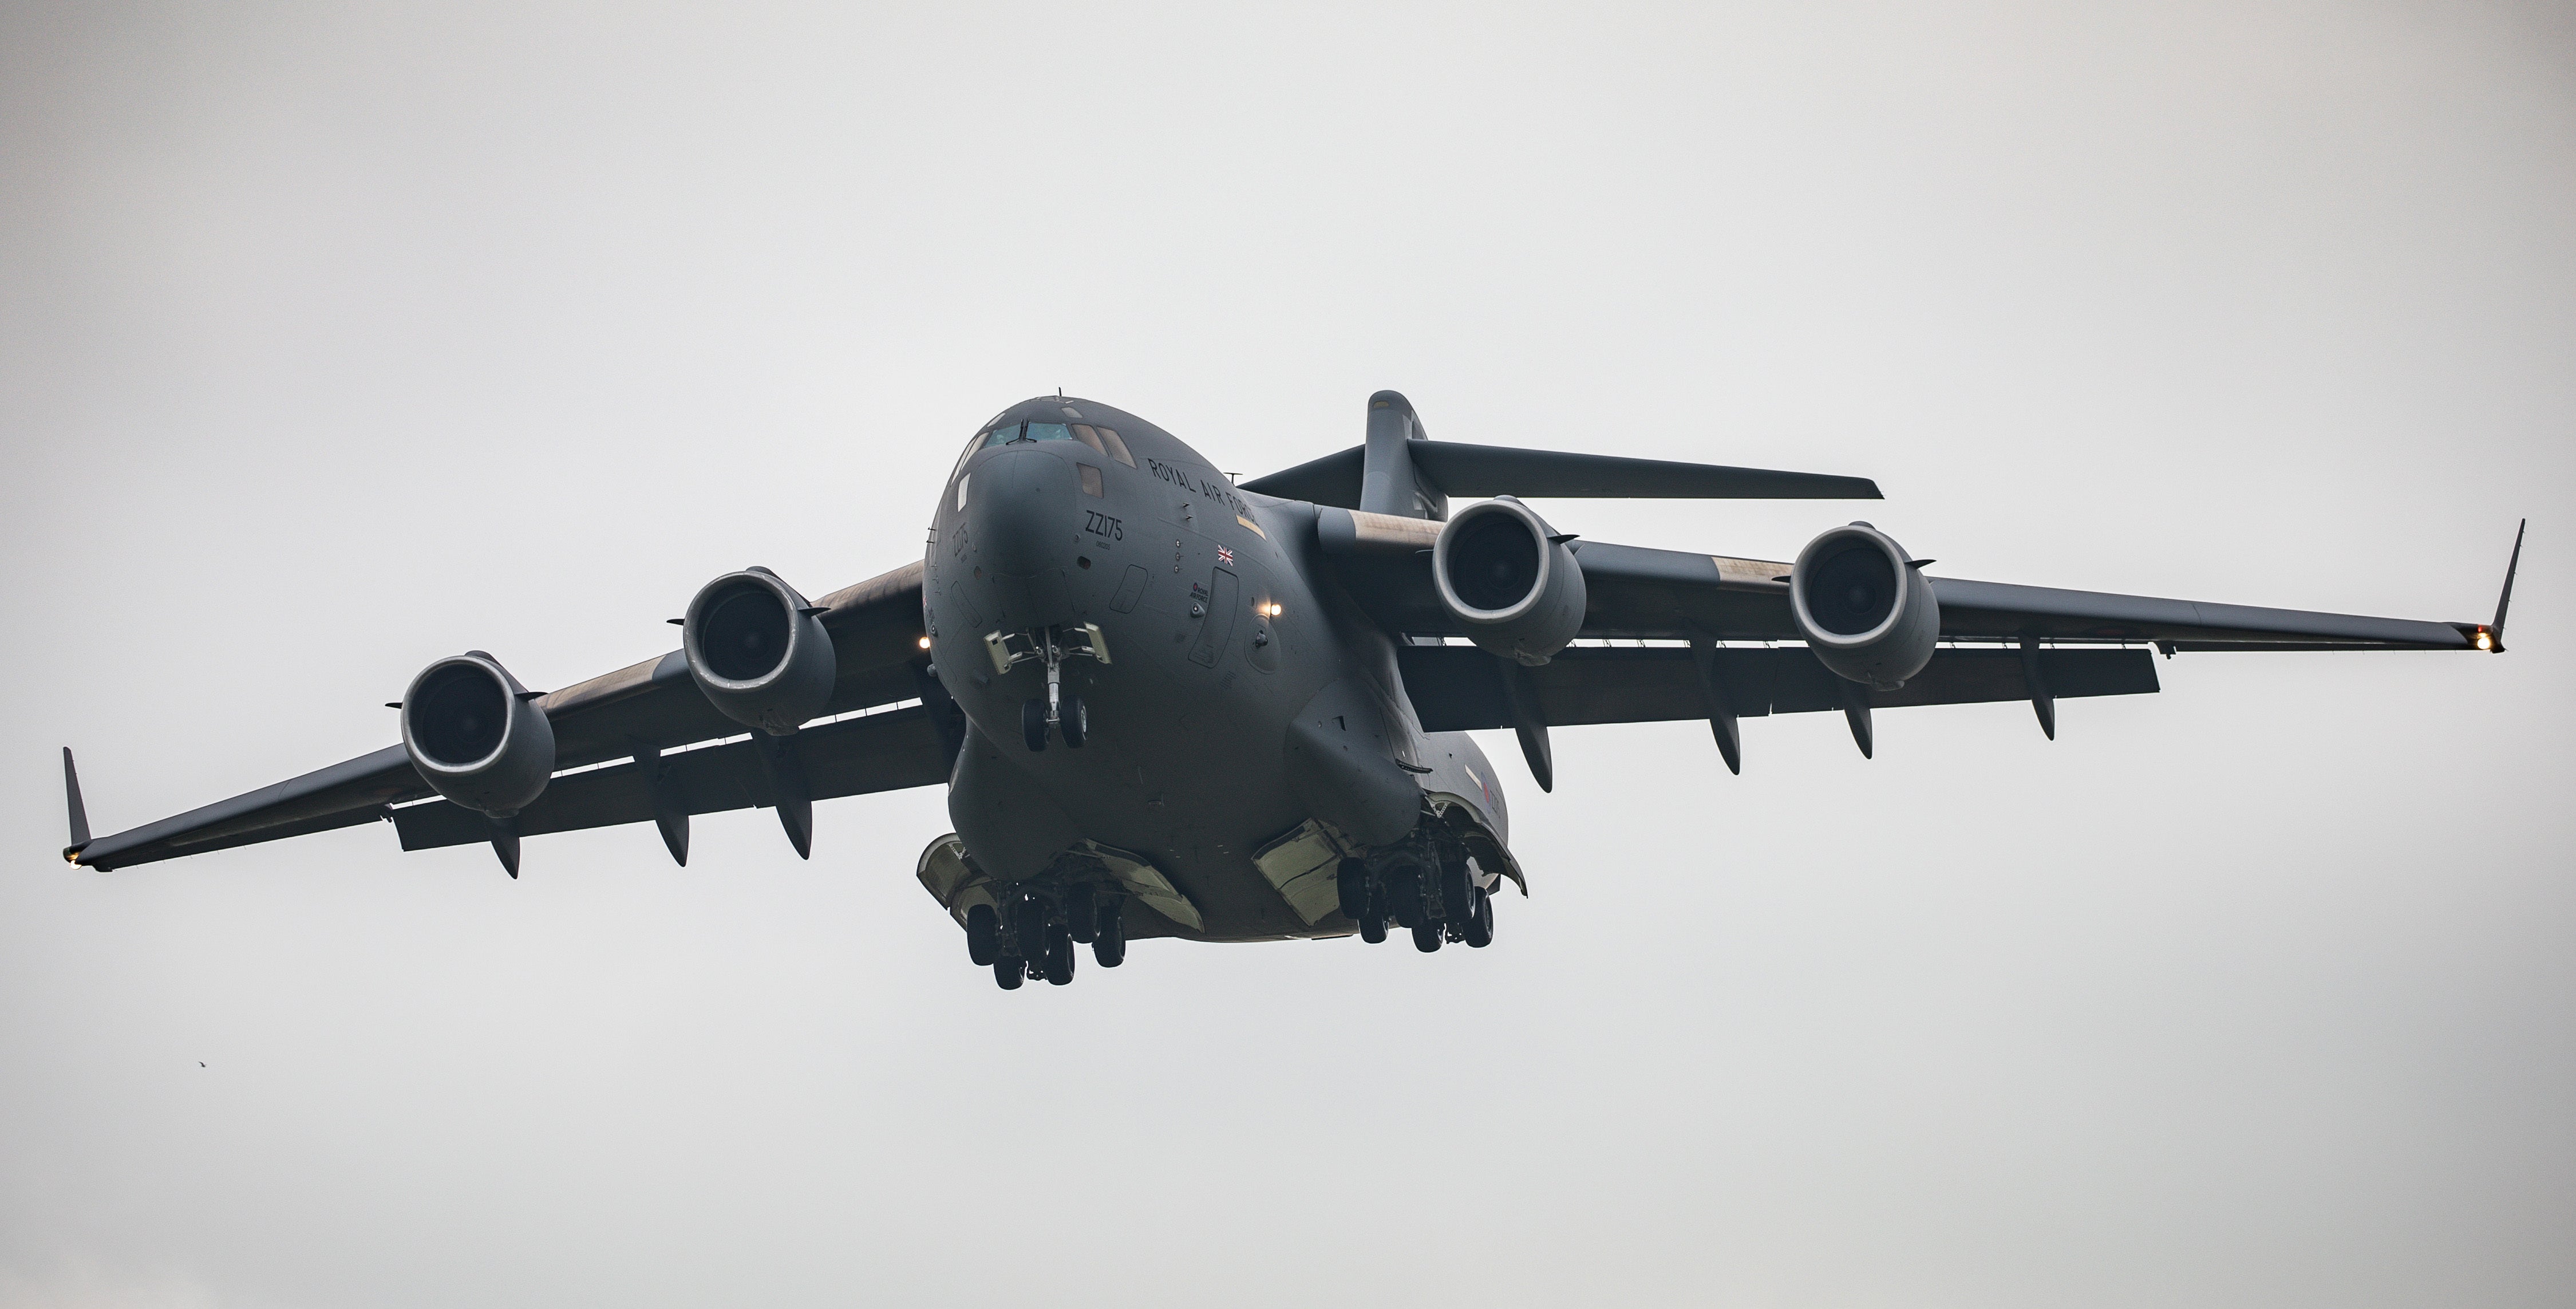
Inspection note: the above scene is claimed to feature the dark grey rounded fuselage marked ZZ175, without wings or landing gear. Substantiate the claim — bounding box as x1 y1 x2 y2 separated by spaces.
922 400 1507 941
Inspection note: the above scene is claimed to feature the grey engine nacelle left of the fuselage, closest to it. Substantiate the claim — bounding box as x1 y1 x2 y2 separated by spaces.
680 567 837 737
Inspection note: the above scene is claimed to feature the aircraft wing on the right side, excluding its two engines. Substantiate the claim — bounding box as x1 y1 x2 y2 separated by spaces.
1317 508 2522 786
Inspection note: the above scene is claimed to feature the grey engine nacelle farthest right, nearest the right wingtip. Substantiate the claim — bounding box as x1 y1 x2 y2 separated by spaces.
1788 523 1940 691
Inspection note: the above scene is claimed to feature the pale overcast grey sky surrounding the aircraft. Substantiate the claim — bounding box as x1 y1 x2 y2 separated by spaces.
0 0 2576 1309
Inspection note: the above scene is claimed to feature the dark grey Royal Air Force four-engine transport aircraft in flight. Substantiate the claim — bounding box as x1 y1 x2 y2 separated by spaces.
62 392 2522 989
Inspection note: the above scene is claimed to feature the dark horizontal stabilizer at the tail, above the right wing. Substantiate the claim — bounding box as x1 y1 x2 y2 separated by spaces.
1244 441 1878 500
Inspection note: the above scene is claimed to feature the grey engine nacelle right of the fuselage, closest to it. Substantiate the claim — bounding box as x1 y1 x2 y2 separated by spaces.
1432 495 1585 665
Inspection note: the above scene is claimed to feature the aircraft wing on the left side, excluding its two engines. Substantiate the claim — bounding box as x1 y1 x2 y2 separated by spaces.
65 562 961 869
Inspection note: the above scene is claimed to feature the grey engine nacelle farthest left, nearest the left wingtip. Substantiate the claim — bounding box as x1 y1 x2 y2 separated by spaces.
402 649 554 817
